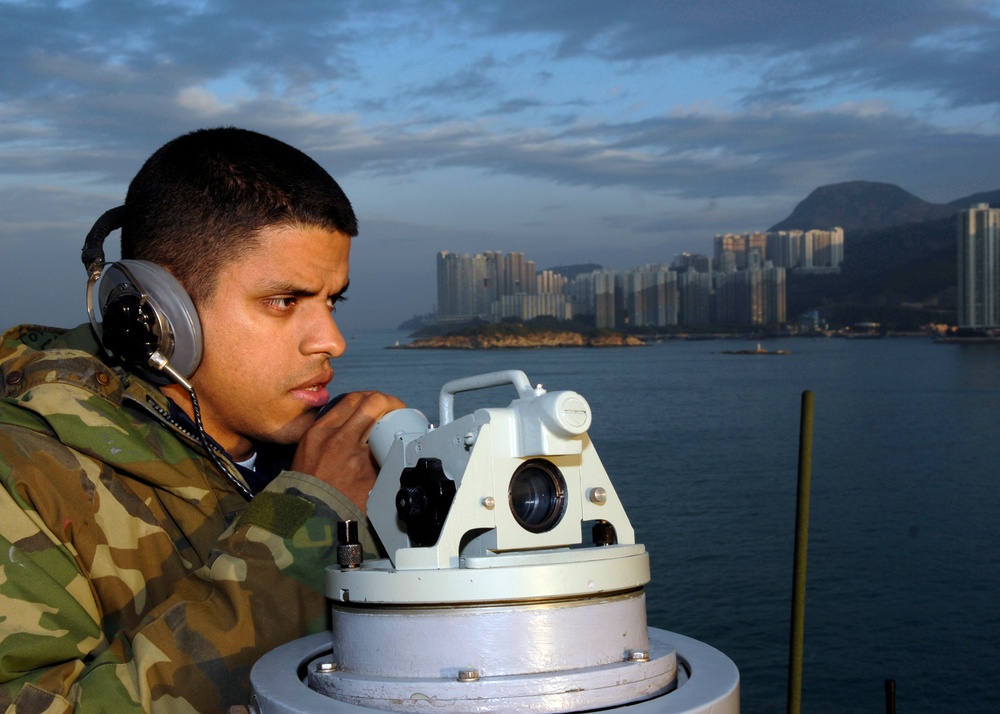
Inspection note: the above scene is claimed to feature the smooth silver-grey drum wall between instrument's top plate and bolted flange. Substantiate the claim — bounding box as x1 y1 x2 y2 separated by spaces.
332 590 649 679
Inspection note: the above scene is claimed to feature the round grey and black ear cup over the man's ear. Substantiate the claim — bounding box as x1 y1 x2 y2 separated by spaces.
98 260 203 378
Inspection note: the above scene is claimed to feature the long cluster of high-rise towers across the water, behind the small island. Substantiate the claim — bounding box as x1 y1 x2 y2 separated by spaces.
434 241 800 329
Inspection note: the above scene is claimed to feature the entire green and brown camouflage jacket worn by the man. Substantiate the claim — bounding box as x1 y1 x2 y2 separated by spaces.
0 326 376 713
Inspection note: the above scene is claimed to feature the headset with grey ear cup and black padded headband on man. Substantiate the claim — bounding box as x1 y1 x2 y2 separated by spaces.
82 206 204 388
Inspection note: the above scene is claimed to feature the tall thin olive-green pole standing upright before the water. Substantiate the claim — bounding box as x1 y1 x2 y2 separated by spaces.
788 390 813 714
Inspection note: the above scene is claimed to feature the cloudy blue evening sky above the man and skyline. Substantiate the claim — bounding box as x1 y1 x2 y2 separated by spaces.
0 0 1000 331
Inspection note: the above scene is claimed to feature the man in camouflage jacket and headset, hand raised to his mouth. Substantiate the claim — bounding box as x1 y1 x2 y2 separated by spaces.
0 128 403 712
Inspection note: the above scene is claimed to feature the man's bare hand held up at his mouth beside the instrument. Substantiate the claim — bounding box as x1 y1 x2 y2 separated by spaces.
292 392 406 511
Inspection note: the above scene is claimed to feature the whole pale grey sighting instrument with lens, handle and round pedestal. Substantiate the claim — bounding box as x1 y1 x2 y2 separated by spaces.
251 371 739 714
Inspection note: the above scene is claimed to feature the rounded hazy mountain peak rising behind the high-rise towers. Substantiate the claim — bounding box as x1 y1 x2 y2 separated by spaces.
768 181 958 235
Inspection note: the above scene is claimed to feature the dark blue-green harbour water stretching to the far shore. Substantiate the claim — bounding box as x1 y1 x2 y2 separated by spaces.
334 332 1000 714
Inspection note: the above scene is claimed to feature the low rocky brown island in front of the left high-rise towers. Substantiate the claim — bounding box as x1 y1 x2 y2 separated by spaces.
396 324 645 350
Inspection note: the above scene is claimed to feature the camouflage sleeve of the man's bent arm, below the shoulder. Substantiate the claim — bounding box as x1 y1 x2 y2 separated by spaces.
0 434 375 713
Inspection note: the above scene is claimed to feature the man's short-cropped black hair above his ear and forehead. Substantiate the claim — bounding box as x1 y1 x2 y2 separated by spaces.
121 127 358 305
